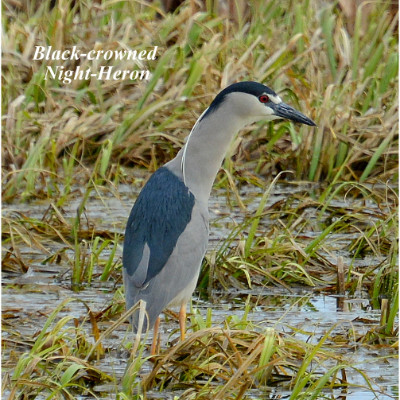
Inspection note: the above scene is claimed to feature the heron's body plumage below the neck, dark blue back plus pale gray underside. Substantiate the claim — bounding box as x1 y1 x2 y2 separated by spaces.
123 166 208 331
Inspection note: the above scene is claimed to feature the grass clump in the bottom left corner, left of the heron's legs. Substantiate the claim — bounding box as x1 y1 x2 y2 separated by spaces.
8 299 111 400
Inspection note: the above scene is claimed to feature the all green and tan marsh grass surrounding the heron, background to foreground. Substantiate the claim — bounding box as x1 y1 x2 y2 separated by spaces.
2 0 398 399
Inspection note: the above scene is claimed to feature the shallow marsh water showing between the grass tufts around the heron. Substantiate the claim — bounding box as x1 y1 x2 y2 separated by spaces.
2 183 398 400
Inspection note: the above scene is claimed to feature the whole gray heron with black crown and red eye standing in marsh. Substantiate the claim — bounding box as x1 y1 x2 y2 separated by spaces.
123 82 315 353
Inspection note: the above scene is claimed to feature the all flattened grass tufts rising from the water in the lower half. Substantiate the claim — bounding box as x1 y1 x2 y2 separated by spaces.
3 178 398 399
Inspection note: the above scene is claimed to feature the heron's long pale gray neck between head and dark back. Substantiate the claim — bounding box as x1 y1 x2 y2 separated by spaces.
169 105 253 203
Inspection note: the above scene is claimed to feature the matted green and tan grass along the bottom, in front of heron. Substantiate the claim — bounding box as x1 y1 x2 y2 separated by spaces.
5 290 394 399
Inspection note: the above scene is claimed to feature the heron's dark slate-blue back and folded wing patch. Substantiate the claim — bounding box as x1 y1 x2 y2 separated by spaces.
122 167 195 288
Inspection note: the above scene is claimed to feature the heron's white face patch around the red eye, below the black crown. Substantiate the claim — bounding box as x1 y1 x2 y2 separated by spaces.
224 92 282 122
